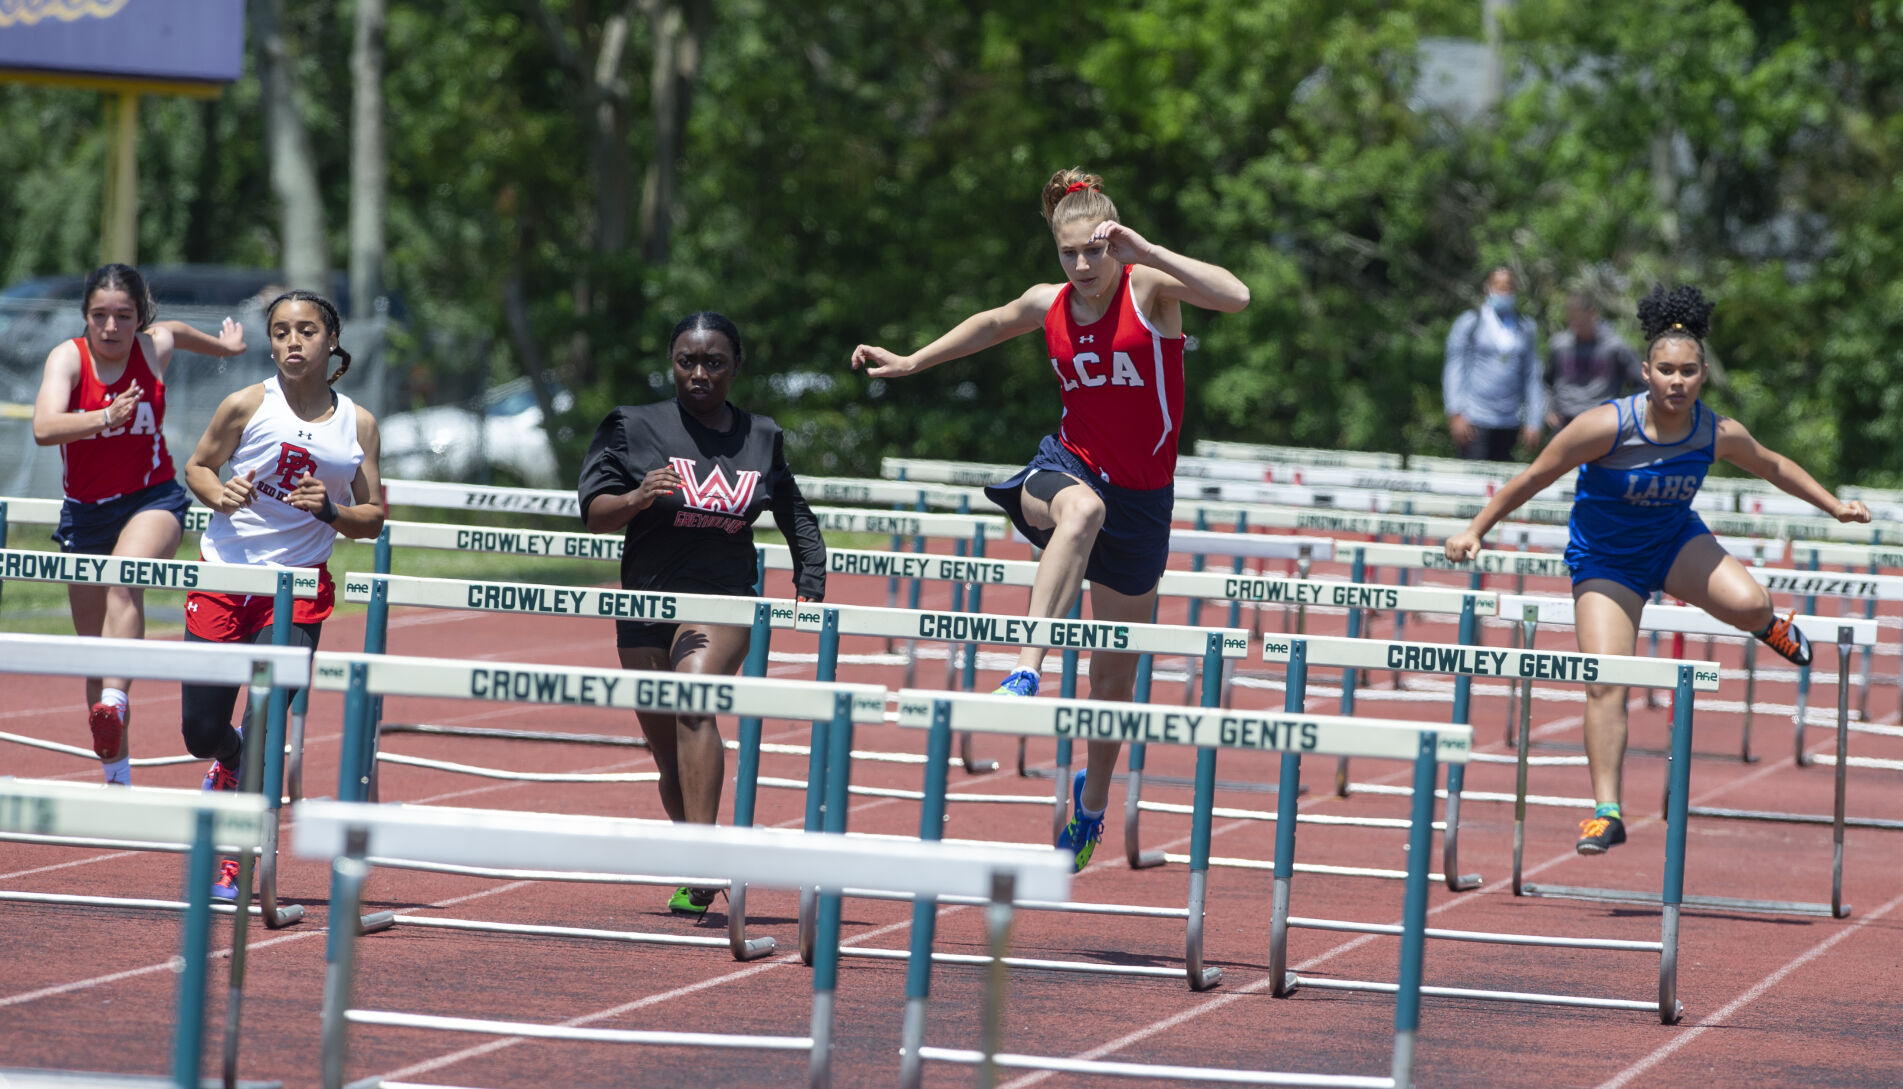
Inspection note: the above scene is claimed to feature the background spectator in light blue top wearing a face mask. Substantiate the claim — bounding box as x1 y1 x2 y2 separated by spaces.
1441 267 1545 461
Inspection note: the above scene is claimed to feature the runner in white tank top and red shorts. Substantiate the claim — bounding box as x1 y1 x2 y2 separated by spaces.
179 291 383 901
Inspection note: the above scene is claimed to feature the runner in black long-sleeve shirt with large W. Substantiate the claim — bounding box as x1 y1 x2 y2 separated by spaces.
579 312 826 916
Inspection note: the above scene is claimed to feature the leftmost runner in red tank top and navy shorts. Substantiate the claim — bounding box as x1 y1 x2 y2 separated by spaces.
32 265 244 782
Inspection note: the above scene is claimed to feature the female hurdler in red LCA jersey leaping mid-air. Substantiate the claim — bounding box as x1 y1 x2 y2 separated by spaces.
853 169 1248 870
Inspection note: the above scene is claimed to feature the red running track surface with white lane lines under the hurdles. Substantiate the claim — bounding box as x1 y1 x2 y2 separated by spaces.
0 544 1903 1089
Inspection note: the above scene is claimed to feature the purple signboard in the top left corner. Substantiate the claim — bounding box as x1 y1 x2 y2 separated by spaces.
0 0 244 84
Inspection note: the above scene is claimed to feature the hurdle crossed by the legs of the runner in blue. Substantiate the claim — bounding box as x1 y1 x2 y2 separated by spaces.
1507 598 1903 920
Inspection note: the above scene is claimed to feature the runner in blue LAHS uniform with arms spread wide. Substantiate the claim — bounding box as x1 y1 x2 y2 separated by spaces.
1446 286 1871 855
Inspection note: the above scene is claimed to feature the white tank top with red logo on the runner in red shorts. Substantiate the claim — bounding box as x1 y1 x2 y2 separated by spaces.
200 375 363 567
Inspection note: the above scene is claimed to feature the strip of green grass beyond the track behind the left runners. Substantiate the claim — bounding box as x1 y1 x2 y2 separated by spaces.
0 525 891 636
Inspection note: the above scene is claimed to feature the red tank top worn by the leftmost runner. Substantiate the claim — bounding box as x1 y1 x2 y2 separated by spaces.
59 337 173 503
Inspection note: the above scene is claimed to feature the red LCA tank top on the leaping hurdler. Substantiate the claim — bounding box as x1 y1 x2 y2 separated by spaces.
1045 267 1184 489
